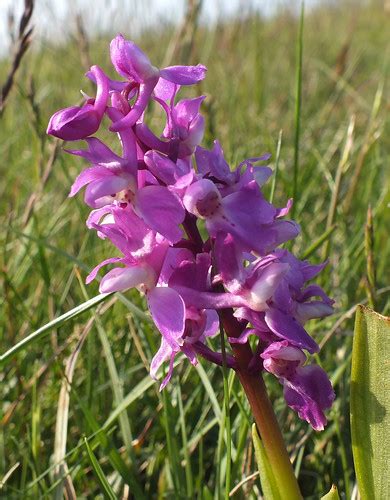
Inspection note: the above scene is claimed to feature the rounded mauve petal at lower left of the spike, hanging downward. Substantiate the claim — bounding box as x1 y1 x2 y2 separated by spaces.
147 287 185 349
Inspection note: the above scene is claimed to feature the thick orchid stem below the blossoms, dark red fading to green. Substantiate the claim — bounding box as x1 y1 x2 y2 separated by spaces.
220 309 302 500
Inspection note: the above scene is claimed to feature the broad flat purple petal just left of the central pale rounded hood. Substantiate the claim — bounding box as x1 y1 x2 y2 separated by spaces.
136 186 185 243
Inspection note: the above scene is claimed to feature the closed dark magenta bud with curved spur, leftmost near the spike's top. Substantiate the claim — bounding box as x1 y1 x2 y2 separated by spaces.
47 66 109 141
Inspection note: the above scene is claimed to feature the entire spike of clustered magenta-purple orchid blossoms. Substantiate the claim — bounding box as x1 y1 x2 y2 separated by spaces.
47 34 334 430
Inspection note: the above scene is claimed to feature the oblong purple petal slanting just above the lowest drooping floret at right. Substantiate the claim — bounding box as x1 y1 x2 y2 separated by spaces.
265 308 320 353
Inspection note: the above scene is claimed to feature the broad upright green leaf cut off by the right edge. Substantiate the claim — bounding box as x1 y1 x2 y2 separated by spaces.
351 305 390 500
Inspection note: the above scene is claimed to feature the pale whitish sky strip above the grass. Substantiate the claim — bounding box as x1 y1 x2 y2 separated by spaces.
0 0 328 55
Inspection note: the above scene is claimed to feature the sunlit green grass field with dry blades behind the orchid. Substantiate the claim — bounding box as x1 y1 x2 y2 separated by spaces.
0 0 390 499
